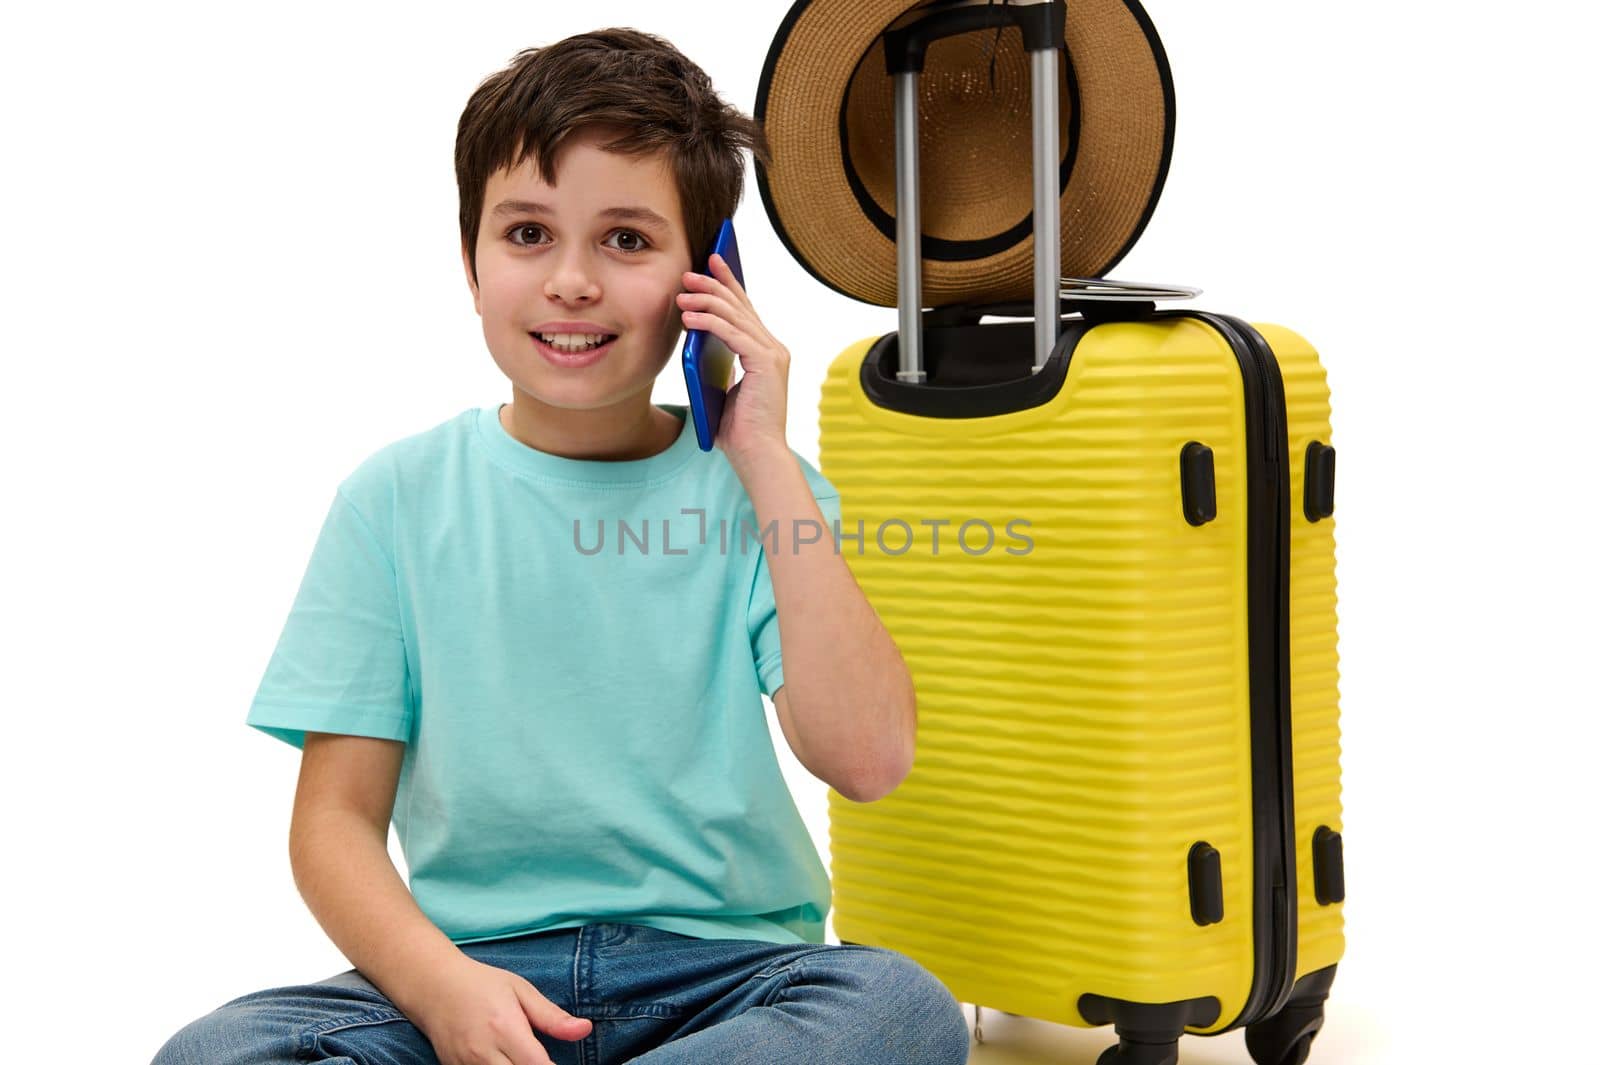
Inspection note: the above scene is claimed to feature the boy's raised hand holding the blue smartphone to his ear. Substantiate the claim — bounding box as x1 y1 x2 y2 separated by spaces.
678 254 789 470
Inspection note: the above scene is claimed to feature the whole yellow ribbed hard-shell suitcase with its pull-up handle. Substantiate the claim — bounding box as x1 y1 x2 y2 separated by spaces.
819 6 1344 1065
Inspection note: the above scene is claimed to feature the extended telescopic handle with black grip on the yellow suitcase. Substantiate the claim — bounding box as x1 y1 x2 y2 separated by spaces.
883 0 1067 384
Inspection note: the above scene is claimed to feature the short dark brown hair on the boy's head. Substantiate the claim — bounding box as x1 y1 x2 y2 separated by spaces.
456 27 771 285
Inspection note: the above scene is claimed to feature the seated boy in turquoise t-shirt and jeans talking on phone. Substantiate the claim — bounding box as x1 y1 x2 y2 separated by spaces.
155 29 968 1065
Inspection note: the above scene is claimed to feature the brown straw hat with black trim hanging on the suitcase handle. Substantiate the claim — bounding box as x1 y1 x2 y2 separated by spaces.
754 0 1174 307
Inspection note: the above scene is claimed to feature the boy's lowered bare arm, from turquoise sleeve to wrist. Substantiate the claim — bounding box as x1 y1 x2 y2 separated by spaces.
290 732 466 1017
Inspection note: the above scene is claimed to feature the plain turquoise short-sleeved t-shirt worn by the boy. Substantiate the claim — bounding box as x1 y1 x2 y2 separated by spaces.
246 405 838 943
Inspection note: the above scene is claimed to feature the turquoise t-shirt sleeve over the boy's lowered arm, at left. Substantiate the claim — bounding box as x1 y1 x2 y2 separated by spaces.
245 486 413 748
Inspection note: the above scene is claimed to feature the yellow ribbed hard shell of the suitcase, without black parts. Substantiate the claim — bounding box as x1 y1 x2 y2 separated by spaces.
819 317 1344 1033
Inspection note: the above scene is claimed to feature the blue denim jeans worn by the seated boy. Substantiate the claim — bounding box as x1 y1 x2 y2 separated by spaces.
152 923 970 1065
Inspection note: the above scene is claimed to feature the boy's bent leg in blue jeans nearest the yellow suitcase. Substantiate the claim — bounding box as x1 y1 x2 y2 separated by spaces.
573 924 970 1065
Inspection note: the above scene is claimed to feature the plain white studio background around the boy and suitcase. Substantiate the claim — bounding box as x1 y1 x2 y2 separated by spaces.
0 0 1600 1065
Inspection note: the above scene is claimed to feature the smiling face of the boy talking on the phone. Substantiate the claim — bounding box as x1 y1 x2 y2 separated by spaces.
461 131 691 409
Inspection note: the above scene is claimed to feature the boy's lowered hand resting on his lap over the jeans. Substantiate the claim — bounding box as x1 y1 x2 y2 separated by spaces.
406 955 592 1065
